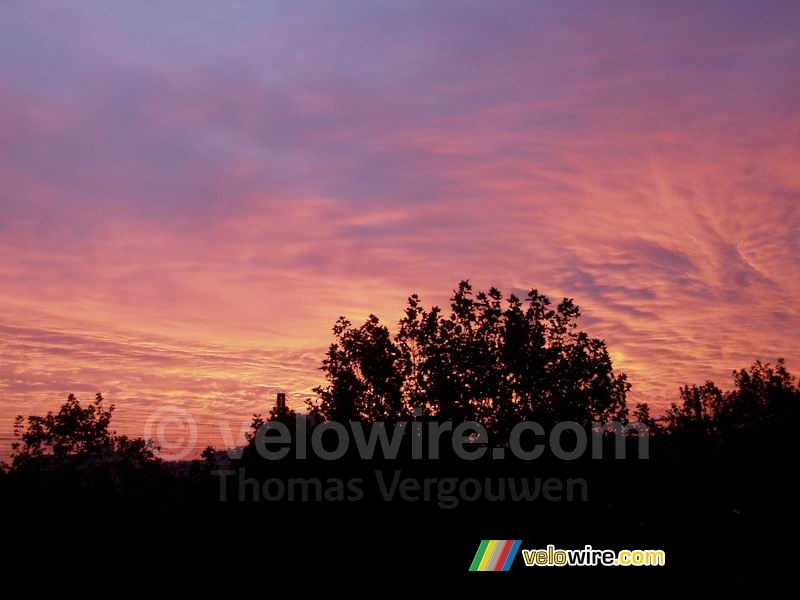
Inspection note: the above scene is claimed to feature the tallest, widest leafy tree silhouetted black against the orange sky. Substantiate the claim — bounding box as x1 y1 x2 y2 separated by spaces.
309 281 630 436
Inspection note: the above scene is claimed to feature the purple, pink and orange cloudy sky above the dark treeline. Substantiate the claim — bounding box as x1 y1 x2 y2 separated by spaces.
0 0 800 454
